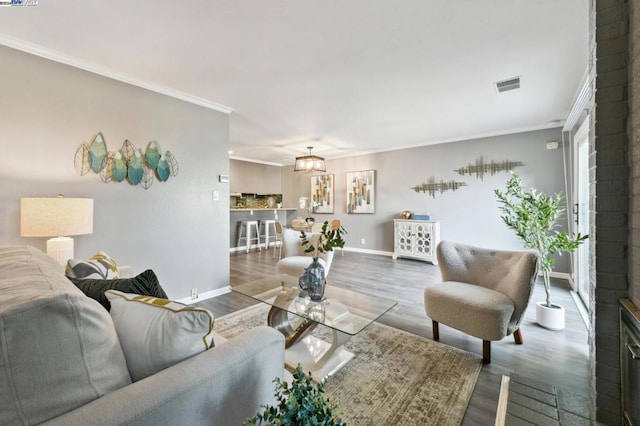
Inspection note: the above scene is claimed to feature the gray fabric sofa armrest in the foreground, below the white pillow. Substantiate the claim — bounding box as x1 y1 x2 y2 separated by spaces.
45 326 284 425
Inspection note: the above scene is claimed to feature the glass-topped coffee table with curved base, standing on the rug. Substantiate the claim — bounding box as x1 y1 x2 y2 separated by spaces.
231 275 397 380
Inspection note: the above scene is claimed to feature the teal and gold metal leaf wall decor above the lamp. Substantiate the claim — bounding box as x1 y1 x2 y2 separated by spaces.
74 132 180 189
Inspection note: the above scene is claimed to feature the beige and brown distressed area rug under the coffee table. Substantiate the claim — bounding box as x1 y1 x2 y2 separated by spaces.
214 304 482 426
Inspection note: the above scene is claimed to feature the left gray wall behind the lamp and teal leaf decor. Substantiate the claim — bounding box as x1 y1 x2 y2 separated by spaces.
0 46 229 298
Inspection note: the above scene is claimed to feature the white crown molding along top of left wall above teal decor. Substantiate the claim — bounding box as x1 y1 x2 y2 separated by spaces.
0 33 233 114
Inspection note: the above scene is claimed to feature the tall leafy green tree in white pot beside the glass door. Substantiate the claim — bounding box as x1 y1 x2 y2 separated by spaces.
494 173 588 330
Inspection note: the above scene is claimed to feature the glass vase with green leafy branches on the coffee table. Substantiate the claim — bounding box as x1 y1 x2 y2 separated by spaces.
299 220 346 300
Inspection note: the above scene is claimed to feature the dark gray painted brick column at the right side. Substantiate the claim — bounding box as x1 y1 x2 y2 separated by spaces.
591 0 640 424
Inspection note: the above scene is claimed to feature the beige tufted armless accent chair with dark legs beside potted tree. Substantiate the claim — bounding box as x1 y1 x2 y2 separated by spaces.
424 241 540 364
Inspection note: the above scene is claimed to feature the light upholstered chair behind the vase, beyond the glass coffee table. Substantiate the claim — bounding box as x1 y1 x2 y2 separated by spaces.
276 229 333 277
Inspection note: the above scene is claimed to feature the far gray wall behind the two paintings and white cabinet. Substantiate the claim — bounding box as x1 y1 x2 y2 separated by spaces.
283 129 570 272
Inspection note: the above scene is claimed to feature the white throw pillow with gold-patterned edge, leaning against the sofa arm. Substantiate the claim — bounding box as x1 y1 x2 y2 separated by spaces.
105 290 213 381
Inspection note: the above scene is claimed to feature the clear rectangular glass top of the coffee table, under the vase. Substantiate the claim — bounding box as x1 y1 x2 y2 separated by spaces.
231 275 397 335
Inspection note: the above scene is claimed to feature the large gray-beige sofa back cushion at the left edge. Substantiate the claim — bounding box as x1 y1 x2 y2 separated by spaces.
0 246 131 424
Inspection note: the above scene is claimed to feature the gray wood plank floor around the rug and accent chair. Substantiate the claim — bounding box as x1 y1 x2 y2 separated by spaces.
198 250 589 425
